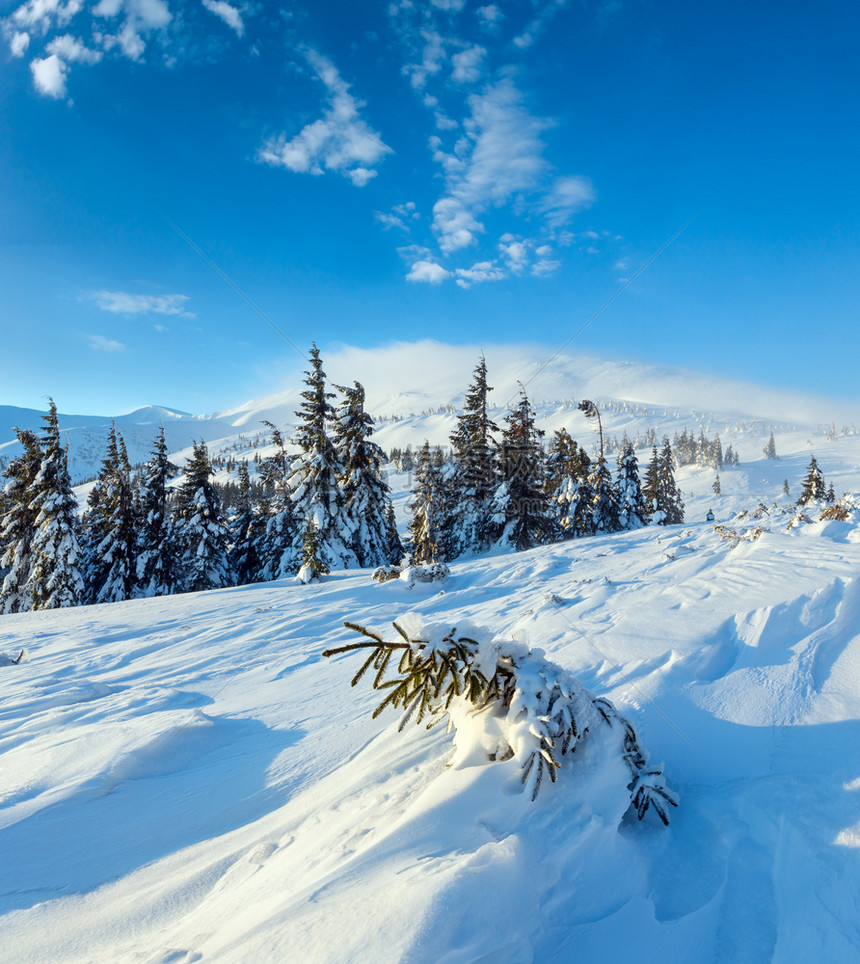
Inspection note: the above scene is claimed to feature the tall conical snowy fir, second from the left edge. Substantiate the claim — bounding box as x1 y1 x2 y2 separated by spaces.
26 398 84 609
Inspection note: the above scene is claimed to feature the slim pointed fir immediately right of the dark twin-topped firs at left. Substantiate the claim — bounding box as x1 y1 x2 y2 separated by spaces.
135 425 179 596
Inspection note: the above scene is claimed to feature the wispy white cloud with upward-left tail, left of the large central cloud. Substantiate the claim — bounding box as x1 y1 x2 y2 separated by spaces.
257 51 391 187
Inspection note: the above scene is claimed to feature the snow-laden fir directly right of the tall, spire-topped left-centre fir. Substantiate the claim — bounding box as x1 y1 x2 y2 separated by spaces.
333 382 404 568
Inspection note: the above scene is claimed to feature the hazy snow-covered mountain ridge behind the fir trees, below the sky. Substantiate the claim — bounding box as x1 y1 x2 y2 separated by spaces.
0 341 853 481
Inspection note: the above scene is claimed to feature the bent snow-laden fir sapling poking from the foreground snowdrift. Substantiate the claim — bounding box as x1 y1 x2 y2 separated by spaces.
323 620 677 824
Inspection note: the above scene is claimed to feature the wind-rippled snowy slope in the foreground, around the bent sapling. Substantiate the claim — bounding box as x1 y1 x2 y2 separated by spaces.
0 519 860 964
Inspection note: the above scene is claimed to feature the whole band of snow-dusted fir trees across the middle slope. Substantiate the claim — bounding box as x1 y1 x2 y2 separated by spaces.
0 345 684 613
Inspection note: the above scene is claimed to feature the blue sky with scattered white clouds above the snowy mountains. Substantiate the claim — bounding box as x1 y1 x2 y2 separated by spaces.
0 0 860 413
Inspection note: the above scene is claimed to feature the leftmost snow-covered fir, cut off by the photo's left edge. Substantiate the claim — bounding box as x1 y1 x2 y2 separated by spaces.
0 428 42 613
